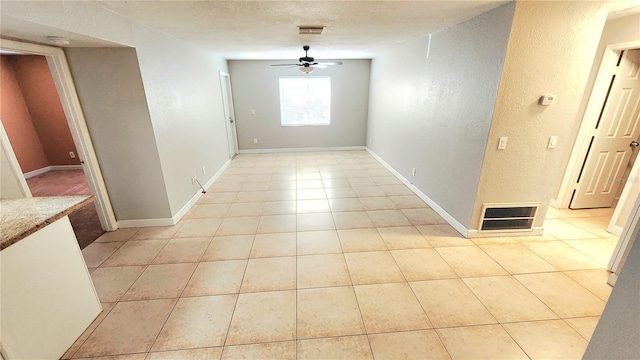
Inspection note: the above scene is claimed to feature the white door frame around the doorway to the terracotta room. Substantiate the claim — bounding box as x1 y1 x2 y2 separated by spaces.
1 39 118 231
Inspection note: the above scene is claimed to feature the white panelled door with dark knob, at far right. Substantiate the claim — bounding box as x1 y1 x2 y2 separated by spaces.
569 50 640 209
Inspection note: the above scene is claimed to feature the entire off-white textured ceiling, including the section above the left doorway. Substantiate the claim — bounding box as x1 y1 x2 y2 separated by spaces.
0 0 640 59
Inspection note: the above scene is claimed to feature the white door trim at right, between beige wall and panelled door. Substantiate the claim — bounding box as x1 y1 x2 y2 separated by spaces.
551 41 640 209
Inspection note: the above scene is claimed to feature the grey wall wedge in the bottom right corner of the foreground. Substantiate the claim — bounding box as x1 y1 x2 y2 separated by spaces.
583 228 640 360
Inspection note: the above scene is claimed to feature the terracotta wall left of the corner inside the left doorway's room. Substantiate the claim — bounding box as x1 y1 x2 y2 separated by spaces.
0 55 49 173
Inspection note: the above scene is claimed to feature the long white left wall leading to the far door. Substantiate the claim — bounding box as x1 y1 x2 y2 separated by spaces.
134 27 233 216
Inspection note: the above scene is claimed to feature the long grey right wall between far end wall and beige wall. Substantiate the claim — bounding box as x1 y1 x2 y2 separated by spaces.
367 3 515 227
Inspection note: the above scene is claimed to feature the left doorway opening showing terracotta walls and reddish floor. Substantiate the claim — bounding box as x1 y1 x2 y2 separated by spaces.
0 54 104 248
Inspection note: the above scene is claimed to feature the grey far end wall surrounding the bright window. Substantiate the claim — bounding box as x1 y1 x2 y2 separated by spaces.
229 60 371 150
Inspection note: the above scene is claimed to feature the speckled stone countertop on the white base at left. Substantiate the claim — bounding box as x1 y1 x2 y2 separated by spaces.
0 195 94 250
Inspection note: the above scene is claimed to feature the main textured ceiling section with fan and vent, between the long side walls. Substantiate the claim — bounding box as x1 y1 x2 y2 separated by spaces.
91 0 505 59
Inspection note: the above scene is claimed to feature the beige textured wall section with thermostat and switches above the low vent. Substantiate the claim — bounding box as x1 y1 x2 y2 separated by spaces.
471 1 608 229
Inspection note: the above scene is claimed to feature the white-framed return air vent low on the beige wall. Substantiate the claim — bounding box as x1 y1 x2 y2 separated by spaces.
480 203 540 232
